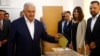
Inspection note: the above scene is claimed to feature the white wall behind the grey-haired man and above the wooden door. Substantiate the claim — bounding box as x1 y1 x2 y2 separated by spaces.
0 0 73 20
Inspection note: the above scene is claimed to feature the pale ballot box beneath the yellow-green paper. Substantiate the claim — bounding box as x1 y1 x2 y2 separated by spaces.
44 48 83 56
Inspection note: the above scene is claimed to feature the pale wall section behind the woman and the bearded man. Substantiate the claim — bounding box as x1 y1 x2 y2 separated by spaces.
73 0 100 20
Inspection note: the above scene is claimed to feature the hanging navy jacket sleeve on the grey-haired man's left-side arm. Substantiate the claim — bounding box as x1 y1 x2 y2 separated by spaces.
8 24 16 56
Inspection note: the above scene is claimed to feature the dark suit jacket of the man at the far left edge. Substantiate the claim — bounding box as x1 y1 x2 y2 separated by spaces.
0 20 10 41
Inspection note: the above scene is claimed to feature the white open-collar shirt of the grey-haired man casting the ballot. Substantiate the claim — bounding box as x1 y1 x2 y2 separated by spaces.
24 16 34 39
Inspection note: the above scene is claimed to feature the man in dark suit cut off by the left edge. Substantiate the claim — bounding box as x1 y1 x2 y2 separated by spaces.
0 10 10 56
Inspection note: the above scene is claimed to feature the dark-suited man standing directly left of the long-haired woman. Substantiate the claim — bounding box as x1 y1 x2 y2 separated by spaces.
62 11 72 47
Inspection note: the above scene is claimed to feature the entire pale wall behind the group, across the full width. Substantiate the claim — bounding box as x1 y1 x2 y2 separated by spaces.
0 0 100 20
